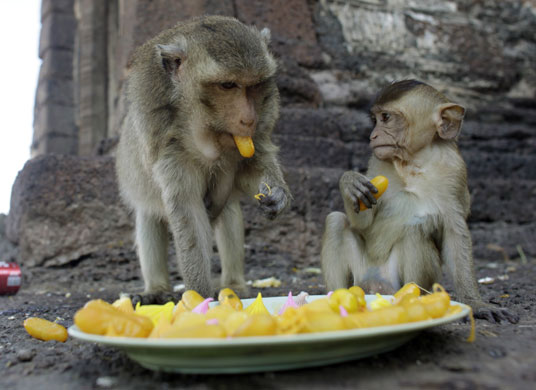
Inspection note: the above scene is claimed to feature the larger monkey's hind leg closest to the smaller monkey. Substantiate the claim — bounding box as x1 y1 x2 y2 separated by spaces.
215 200 246 292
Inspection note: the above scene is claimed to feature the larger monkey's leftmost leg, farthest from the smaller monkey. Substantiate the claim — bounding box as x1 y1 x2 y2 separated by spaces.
133 210 171 304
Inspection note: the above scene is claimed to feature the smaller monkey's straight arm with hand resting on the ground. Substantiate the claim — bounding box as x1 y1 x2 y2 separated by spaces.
441 215 519 323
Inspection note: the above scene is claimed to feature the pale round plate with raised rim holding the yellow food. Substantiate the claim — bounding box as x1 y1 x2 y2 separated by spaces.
69 295 469 374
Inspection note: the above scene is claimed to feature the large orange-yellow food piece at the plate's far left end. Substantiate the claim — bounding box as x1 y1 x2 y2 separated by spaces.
74 299 154 337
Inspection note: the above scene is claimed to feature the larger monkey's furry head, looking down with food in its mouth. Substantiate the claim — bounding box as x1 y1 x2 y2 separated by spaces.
156 17 279 156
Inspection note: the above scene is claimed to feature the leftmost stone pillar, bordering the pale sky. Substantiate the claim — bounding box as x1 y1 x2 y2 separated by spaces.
31 0 78 157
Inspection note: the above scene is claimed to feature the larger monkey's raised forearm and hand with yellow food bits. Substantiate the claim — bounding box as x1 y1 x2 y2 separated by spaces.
236 139 292 219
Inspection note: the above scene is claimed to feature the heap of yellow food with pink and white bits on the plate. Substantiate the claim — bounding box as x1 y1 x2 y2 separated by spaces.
74 283 473 339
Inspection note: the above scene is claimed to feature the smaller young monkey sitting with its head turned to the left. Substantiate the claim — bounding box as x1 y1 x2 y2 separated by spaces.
322 80 517 322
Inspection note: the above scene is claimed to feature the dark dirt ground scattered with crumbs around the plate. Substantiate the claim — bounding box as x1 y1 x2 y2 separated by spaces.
0 250 536 390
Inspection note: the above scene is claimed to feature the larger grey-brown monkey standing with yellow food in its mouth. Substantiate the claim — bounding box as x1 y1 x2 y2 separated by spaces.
117 16 291 303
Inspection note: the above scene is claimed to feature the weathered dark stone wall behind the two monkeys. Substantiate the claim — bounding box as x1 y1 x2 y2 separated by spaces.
7 0 536 264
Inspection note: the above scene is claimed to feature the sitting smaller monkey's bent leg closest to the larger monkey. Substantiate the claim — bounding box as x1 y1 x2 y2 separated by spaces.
320 211 364 291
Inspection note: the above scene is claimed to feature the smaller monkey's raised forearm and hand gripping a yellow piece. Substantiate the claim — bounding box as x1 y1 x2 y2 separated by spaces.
339 171 377 230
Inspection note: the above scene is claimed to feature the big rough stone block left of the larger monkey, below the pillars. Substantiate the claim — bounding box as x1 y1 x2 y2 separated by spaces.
7 155 133 266
